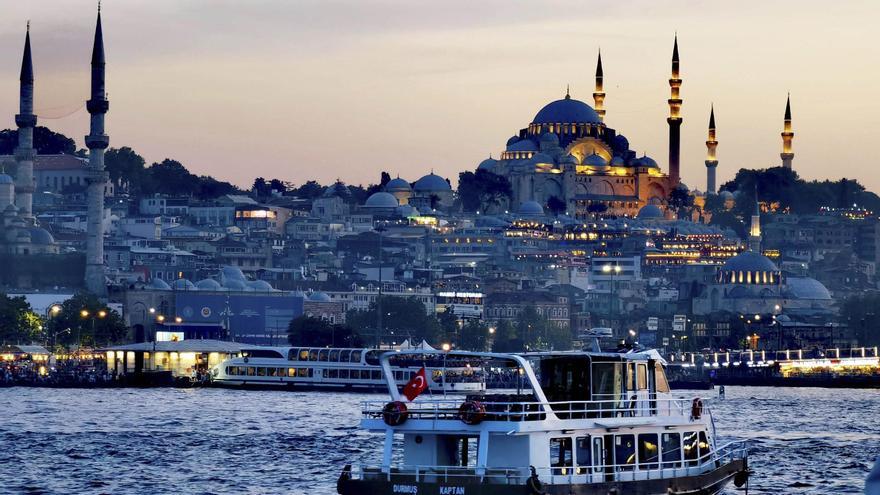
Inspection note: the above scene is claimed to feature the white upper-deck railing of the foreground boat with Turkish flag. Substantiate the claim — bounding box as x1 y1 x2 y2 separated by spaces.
362 396 710 422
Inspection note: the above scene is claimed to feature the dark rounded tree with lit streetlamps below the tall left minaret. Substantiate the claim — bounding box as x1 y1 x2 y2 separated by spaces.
48 293 128 347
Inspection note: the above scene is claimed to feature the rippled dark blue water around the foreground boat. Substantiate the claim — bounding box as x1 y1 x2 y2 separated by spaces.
0 387 880 494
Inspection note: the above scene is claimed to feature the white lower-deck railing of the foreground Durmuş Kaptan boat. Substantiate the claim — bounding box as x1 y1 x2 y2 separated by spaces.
350 441 749 485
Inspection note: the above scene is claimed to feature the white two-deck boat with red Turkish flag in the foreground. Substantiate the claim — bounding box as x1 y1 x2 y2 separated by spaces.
337 351 749 495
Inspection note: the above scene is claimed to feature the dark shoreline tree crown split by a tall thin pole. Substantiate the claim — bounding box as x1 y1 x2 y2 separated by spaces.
346 296 443 344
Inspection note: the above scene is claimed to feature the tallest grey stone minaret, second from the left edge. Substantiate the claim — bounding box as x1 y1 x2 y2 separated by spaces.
85 5 110 295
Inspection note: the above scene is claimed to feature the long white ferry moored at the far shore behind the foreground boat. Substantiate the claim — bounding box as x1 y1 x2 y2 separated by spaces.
211 347 486 393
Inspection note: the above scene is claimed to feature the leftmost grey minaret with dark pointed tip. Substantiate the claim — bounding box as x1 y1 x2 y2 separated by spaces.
15 22 37 222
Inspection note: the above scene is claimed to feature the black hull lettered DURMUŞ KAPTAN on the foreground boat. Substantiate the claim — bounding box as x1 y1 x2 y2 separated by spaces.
337 459 748 495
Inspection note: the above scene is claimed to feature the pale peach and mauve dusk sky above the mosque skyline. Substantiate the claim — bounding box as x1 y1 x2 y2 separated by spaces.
0 0 880 191
